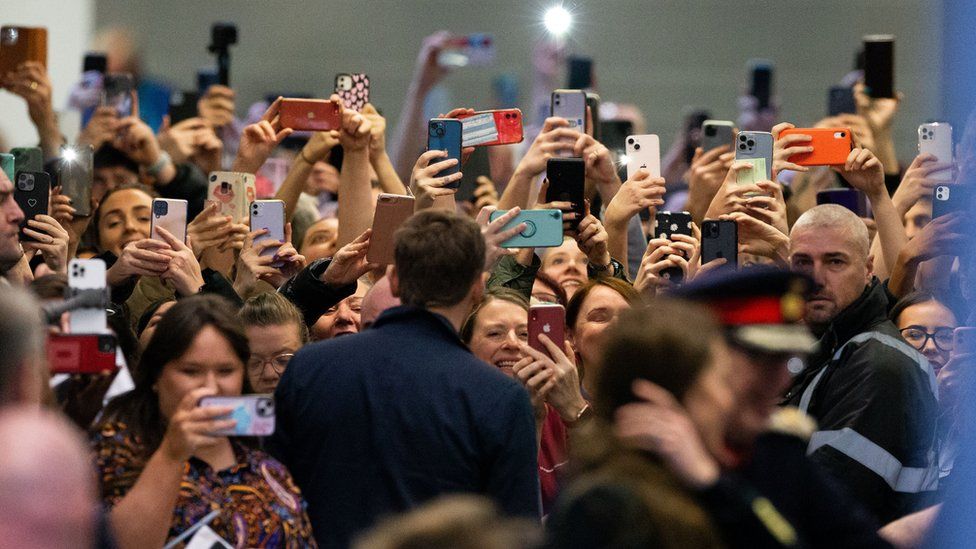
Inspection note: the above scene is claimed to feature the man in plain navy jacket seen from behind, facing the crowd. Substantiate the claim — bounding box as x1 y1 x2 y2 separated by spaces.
269 211 540 547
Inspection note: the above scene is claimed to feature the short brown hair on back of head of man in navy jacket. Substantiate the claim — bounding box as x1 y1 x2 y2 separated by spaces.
394 210 485 308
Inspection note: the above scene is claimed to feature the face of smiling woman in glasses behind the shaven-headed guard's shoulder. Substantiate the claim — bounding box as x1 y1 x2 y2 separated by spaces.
890 291 959 374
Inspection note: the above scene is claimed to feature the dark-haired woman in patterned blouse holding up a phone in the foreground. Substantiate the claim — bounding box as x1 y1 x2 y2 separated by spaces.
93 296 314 547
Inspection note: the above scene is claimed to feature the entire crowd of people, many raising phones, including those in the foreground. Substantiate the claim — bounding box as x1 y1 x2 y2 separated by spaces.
0 18 976 549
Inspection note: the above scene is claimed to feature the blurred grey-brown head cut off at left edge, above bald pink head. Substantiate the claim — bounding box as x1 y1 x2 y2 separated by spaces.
0 287 47 405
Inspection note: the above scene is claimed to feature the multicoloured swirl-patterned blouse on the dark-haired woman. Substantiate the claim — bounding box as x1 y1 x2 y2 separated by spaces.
92 422 316 548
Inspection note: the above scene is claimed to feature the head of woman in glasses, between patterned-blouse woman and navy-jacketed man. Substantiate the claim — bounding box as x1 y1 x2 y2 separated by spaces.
239 292 308 393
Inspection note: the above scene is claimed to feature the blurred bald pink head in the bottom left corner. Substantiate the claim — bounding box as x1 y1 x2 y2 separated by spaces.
0 407 97 549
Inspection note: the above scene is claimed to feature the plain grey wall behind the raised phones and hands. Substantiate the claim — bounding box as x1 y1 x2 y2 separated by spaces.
95 0 942 159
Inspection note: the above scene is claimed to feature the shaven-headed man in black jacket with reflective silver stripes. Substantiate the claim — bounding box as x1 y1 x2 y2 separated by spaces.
786 205 939 523
